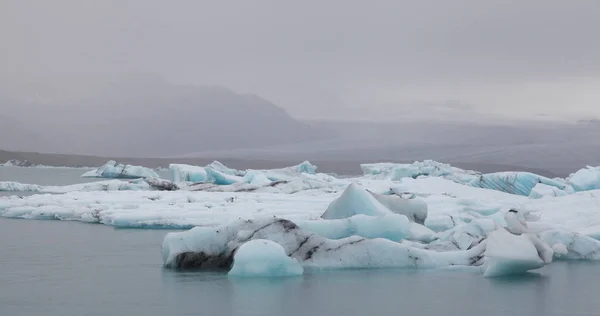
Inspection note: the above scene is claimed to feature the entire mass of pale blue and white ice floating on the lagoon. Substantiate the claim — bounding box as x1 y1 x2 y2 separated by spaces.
0 161 600 276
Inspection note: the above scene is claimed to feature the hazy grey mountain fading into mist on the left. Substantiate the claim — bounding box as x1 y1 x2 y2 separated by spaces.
0 76 328 157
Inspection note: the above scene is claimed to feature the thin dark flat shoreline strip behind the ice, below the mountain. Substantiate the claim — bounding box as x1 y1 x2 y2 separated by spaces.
0 150 564 180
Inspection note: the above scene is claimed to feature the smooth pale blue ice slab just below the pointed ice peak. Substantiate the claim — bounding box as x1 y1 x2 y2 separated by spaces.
296 214 411 241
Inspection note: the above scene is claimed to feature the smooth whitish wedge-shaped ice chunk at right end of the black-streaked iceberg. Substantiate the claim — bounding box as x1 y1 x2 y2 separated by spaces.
483 228 544 277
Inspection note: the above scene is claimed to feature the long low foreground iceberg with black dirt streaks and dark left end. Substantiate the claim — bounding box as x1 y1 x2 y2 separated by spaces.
162 218 485 269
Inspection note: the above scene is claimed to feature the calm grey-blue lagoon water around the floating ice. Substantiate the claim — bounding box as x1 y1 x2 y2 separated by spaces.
0 168 600 316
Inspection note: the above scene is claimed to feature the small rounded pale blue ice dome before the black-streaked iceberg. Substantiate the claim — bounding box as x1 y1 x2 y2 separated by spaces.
228 239 304 277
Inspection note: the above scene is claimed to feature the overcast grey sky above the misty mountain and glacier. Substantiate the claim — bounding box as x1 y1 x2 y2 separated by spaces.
0 0 600 119
